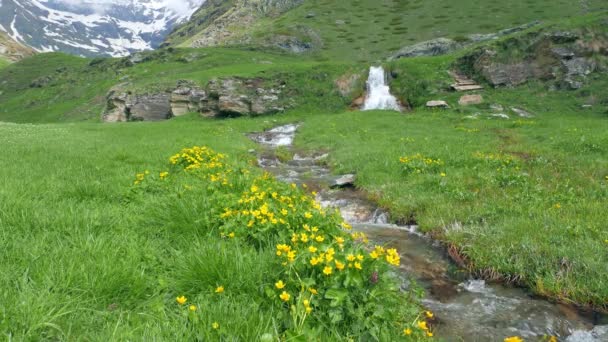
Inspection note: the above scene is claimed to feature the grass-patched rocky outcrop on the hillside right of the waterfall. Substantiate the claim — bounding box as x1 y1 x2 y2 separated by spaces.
456 27 608 89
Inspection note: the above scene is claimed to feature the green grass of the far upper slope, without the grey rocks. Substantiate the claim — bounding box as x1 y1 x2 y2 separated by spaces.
232 0 607 62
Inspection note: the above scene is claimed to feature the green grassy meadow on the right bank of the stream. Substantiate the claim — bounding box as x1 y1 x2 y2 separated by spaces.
296 82 608 309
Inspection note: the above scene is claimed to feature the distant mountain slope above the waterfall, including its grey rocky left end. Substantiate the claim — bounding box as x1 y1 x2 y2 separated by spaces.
166 0 608 61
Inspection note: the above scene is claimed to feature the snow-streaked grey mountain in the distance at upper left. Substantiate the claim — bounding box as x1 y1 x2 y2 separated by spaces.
0 0 205 57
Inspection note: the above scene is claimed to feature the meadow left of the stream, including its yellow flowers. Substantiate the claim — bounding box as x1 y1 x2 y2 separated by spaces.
0 116 425 341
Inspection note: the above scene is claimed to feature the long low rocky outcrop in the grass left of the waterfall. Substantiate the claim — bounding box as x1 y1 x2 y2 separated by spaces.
103 77 290 122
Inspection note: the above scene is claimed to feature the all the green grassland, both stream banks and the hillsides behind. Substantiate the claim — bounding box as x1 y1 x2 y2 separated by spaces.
0 6 608 341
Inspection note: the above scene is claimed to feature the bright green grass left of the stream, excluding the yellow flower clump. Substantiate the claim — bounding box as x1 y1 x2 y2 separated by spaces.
0 116 426 341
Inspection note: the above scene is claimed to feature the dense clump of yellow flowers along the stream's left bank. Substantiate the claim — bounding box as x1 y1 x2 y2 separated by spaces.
161 147 414 336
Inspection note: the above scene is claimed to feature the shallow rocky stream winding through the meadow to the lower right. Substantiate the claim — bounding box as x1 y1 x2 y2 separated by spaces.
251 125 608 342
